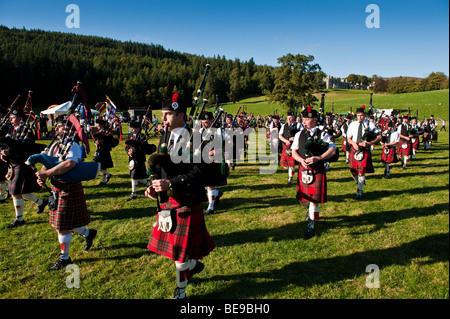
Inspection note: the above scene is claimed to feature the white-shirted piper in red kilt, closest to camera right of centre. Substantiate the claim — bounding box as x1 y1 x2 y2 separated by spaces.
291 106 336 238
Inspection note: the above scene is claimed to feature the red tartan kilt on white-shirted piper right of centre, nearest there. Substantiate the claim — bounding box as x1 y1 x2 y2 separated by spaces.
296 163 327 204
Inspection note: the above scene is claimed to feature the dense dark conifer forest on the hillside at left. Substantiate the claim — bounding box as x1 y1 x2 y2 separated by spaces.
0 26 274 110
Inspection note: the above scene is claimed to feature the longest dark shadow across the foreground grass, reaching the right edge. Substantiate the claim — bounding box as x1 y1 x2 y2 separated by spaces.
195 233 449 299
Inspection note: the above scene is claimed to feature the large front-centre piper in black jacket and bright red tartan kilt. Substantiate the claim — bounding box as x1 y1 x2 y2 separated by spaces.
145 93 215 299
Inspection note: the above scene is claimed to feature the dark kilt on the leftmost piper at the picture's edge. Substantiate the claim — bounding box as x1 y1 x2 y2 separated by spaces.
8 164 42 195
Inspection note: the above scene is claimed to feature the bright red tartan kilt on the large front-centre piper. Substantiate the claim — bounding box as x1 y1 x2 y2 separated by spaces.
147 197 216 262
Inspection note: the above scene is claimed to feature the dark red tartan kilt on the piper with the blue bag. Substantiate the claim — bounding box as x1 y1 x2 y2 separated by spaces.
49 180 91 230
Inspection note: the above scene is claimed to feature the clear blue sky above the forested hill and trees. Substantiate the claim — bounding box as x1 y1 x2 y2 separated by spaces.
0 0 449 77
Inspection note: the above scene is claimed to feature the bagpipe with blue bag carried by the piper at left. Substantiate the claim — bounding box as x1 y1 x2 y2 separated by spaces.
25 114 101 183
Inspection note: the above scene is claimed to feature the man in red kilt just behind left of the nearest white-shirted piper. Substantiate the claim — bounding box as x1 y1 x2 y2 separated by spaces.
278 112 298 185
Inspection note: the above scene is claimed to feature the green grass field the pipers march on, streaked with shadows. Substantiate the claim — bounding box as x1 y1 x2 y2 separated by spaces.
0 90 449 299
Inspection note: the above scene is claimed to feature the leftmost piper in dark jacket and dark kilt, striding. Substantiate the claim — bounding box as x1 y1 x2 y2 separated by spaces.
1 109 48 228
